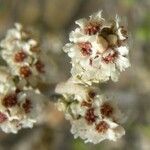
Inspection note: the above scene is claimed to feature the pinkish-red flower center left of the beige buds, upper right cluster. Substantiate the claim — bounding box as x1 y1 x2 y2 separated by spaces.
78 42 92 56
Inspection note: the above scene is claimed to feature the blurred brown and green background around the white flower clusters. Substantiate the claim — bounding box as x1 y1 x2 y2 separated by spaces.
0 0 150 150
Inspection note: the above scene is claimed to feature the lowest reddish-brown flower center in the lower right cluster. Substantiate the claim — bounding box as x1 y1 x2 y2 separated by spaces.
96 121 109 133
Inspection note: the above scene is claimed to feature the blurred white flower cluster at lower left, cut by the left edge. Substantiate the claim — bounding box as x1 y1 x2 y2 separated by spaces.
0 67 46 133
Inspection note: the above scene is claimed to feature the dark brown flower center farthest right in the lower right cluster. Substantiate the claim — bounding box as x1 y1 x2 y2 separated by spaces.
100 103 113 117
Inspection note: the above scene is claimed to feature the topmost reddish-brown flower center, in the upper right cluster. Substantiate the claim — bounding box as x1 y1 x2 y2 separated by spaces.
84 22 100 35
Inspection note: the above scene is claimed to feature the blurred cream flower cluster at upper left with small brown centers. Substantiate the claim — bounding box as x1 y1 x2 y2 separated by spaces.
0 23 50 87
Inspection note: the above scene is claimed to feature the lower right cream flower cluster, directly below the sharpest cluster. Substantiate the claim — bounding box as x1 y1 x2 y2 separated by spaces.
56 80 125 144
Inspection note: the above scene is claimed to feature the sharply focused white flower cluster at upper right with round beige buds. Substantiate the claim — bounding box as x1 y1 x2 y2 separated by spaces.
63 11 130 84
